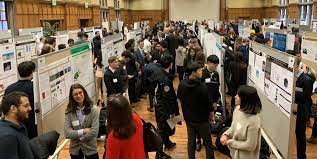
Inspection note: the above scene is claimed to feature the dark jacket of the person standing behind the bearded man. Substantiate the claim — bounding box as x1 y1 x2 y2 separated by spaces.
4 80 37 139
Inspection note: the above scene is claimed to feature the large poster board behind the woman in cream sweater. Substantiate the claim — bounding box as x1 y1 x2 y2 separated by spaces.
247 41 296 158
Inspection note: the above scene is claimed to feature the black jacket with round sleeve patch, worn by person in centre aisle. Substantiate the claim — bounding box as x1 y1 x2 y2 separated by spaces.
155 68 179 128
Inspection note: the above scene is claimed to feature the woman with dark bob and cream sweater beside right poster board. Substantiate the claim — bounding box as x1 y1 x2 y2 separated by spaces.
220 85 262 159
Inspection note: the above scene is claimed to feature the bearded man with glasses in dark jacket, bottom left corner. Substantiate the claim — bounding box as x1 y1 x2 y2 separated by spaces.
0 92 34 159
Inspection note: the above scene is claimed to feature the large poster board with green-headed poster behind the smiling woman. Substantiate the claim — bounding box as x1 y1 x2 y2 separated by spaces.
34 43 95 139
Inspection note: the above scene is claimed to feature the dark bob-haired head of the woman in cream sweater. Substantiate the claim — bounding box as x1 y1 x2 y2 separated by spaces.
235 85 262 115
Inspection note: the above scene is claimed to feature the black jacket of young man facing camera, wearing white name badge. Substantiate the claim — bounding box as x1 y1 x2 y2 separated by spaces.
201 68 220 108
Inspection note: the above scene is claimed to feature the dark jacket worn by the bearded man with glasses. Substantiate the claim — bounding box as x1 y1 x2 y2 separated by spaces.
0 120 34 159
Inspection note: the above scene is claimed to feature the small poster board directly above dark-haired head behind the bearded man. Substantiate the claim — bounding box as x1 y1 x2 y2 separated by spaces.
14 35 37 65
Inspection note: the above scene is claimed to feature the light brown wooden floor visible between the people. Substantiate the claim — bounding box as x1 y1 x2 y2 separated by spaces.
59 80 317 159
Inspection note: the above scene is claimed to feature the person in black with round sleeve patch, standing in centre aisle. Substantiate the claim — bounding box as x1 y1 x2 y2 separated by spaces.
155 55 179 156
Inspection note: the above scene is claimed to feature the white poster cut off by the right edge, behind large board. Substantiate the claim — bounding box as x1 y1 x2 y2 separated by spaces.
302 37 317 62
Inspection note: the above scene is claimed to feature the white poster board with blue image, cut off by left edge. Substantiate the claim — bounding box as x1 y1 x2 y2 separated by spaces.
0 38 18 101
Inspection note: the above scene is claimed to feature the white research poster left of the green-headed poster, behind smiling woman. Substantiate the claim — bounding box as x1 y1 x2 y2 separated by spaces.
38 56 73 117
